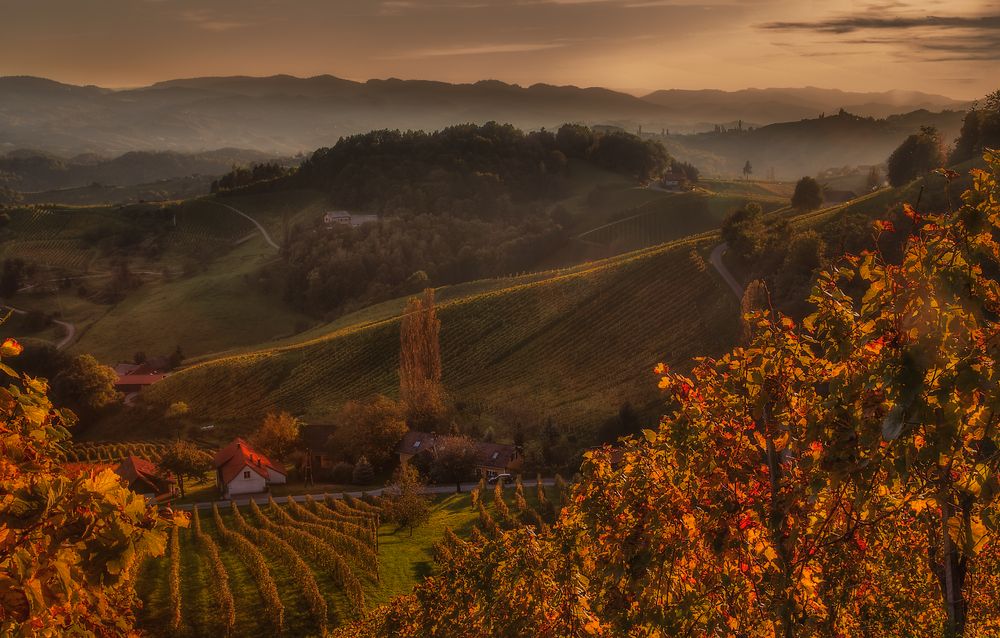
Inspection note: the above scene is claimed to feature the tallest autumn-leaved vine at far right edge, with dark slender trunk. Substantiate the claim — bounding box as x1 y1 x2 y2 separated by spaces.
812 159 1000 636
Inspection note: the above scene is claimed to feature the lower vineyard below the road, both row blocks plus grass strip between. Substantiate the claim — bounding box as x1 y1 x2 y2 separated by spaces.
137 479 567 637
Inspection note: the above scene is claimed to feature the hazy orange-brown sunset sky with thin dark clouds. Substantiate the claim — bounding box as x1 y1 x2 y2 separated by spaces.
0 0 1000 99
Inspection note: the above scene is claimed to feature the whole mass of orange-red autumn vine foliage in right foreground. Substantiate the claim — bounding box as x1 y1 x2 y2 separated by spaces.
338 154 1000 638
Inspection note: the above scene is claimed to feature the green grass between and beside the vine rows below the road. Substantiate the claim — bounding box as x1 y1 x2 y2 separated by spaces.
136 487 558 637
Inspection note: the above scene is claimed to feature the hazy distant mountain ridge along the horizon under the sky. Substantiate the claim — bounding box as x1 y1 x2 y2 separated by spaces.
0 75 967 156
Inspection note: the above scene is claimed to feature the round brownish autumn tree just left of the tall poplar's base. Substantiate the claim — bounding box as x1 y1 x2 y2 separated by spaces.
327 395 407 470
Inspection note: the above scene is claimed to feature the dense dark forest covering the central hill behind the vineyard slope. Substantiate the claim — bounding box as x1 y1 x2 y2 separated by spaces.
256 123 670 316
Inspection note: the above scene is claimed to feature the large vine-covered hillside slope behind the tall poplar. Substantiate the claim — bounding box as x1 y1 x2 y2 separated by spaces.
146 232 738 432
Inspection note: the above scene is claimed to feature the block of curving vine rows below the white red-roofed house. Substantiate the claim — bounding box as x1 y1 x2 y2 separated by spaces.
137 497 379 637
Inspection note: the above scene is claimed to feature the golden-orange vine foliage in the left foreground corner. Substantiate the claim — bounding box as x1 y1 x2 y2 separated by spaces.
0 339 185 637
